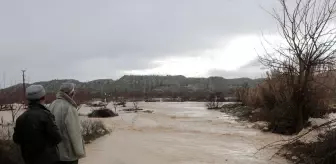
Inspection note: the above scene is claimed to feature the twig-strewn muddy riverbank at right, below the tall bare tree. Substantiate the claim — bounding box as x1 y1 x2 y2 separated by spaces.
217 104 336 164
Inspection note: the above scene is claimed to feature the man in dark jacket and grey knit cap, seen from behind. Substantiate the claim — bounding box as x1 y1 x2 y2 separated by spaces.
13 85 61 164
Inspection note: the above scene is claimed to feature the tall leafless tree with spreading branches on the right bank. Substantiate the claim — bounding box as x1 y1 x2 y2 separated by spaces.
260 0 336 131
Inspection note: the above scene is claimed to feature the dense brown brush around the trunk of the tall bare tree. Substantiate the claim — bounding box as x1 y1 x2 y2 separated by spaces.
236 72 334 134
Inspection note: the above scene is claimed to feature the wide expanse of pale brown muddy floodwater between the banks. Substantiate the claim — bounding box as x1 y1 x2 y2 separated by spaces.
80 102 287 164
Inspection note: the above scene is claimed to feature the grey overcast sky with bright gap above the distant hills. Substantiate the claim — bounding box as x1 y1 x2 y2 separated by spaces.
0 0 277 83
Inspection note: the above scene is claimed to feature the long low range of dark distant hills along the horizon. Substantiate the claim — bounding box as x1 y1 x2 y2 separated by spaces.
2 75 262 96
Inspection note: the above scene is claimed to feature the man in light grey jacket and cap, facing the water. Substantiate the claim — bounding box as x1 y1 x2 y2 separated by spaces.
49 83 85 164
